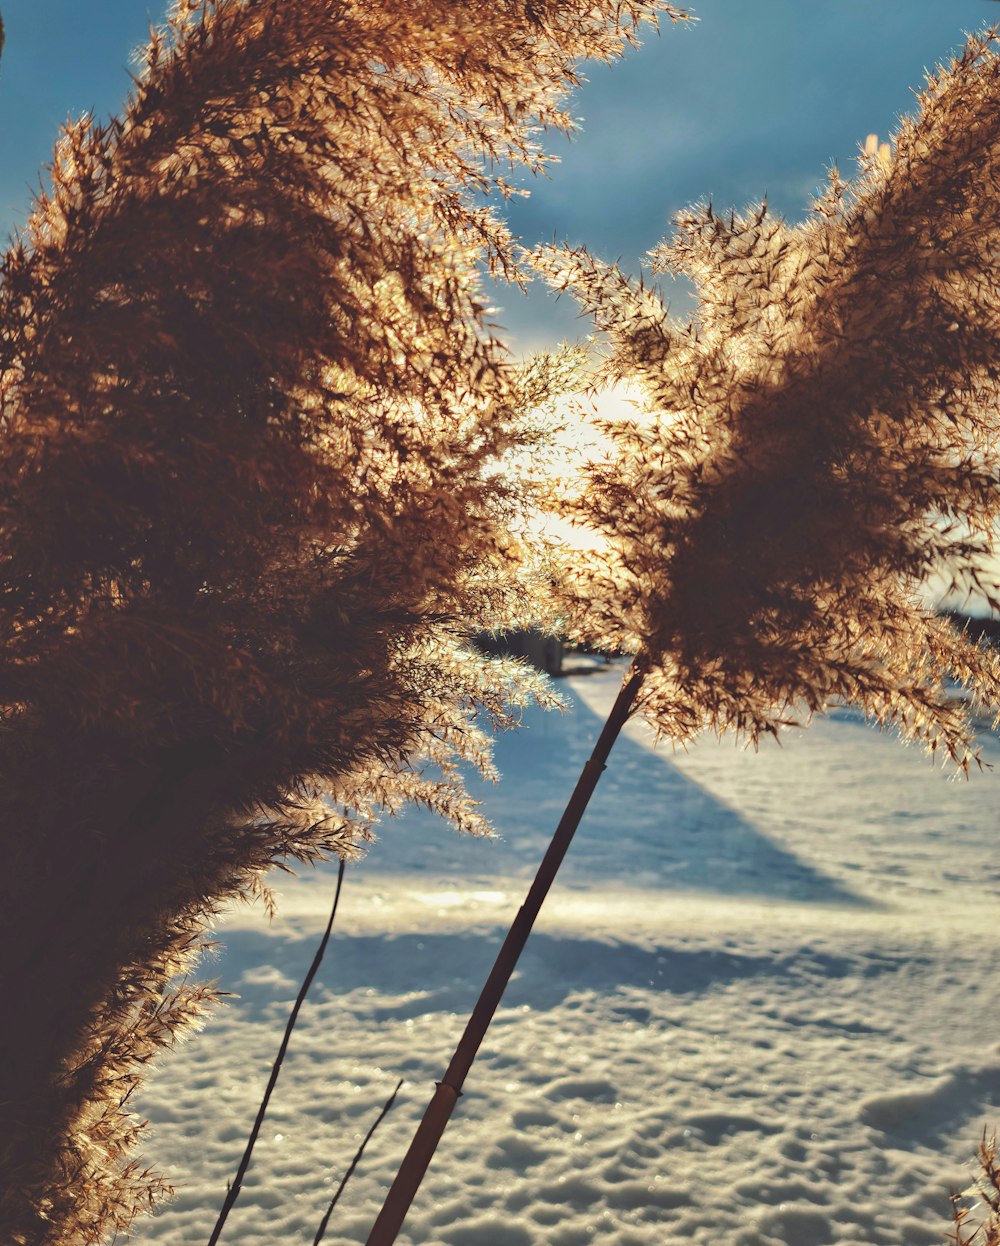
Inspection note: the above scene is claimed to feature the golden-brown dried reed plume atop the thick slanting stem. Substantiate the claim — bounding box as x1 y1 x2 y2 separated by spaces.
535 31 1000 769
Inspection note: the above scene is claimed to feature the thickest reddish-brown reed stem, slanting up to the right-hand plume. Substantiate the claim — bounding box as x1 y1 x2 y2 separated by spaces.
367 662 645 1246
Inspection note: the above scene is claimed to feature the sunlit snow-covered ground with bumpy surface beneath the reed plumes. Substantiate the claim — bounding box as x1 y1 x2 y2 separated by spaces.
133 668 1000 1246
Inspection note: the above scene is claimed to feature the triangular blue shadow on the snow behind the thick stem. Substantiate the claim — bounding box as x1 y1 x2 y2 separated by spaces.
356 687 872 906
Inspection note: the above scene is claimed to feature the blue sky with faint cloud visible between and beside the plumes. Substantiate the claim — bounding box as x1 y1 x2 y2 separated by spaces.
0 0 1000 349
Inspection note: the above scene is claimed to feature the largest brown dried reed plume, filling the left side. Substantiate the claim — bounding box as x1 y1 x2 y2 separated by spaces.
0 0 679 1246
